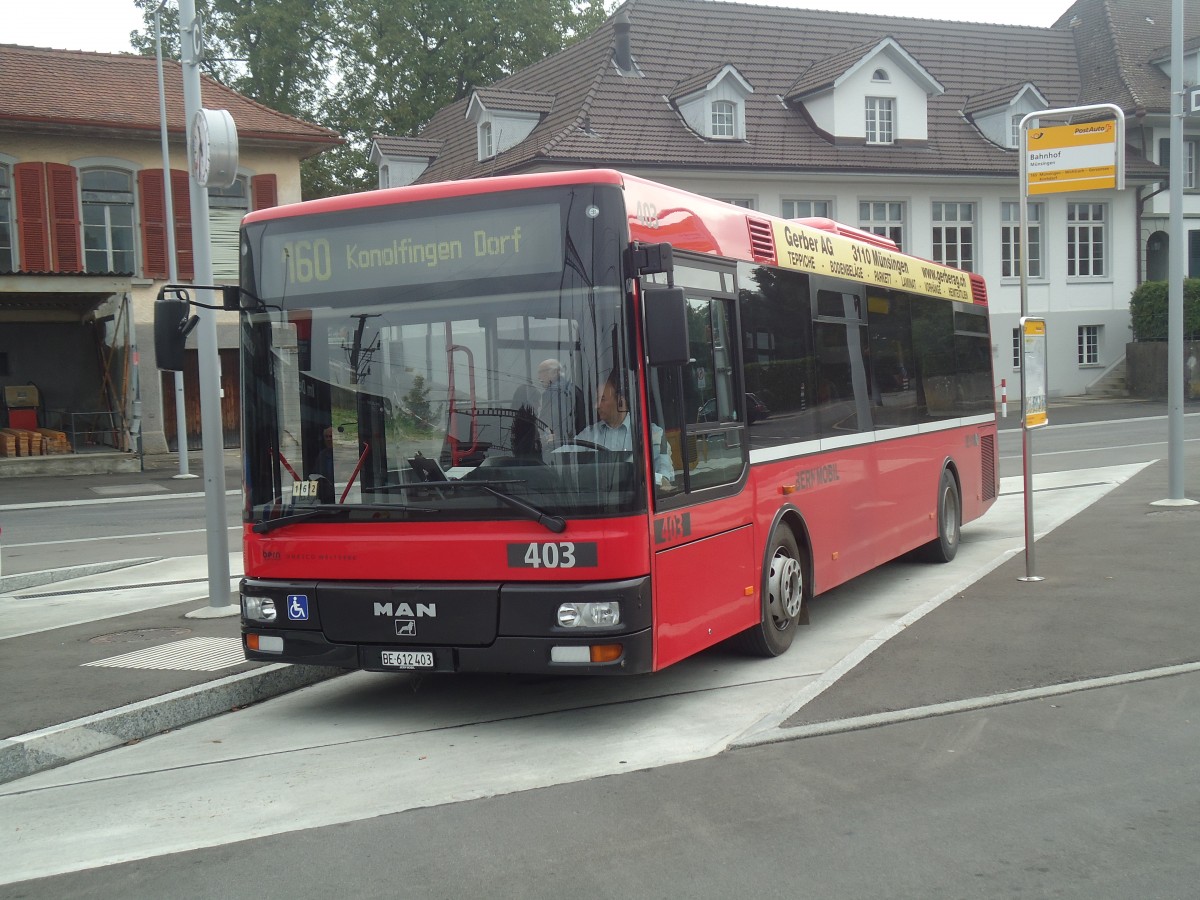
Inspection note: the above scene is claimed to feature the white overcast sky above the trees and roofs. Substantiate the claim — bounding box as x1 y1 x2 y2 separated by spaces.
7 0 1070 53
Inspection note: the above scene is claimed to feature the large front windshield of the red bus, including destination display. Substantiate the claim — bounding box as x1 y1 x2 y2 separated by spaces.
241 186 647 523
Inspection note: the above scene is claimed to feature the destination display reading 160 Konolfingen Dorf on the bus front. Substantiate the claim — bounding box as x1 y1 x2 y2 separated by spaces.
258 203 563 300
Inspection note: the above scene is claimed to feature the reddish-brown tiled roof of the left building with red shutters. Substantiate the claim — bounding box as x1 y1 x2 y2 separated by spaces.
0 44 342 156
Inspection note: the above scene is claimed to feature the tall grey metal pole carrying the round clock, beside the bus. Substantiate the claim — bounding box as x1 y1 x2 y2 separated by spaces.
179 0 238 616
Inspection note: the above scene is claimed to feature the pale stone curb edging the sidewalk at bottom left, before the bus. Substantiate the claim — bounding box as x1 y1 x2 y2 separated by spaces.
0 662 344 784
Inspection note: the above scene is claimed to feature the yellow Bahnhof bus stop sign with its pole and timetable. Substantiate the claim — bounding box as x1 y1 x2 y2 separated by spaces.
1016 103 1124 581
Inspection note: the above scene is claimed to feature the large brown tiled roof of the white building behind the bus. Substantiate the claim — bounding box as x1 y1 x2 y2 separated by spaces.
408 0 1166 181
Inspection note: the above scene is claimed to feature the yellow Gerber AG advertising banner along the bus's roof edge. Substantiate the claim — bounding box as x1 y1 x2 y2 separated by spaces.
773 222 973 302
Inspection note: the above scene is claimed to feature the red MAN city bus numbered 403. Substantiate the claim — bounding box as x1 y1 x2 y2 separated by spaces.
206 170 998 674
